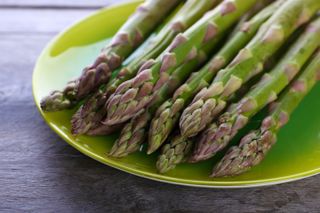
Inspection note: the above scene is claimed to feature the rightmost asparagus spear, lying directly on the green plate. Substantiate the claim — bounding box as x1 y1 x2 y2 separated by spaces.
211 51 320 177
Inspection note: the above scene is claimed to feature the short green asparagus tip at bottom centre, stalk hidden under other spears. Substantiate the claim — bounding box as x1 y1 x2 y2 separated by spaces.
156 135 193 173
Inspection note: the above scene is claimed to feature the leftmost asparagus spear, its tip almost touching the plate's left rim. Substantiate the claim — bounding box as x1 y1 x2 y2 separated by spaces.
41 0 181 111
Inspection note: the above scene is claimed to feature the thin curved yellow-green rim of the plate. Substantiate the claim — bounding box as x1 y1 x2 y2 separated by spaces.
32 0 320 189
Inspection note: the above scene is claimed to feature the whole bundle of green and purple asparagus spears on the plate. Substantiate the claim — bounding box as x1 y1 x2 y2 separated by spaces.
41 0 320 177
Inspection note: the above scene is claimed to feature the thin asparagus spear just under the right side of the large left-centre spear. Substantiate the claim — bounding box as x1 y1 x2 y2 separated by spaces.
109 50 210 157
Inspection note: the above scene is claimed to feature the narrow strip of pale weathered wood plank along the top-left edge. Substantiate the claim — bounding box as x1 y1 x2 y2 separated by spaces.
0 0 130 9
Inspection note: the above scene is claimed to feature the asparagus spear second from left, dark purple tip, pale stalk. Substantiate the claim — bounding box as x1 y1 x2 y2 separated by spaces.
71 0 220 134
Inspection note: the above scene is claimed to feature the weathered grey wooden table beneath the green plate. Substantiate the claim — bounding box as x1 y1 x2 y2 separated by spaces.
0 0 320 213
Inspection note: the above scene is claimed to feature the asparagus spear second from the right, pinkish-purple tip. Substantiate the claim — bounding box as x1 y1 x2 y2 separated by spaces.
190 18 320 162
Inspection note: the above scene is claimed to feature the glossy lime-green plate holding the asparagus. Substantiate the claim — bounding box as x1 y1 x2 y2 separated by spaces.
33 1 320 188
